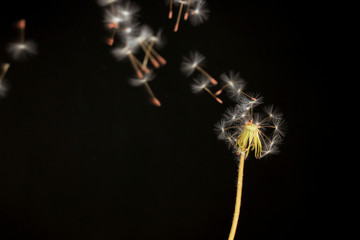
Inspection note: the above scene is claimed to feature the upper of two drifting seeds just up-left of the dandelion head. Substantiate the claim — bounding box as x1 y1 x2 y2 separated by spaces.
181 52 217 85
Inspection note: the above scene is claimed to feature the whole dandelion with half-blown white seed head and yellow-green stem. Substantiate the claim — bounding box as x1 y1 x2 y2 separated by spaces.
215 99 284 240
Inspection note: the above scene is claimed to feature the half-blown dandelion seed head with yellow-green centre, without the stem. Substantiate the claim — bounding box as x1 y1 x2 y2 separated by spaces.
215 101 284 158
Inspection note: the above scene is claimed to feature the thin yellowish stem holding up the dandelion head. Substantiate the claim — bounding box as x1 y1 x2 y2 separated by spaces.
228 152 245 240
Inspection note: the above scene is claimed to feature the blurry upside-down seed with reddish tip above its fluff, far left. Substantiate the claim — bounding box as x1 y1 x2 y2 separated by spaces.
7 19 37 60
